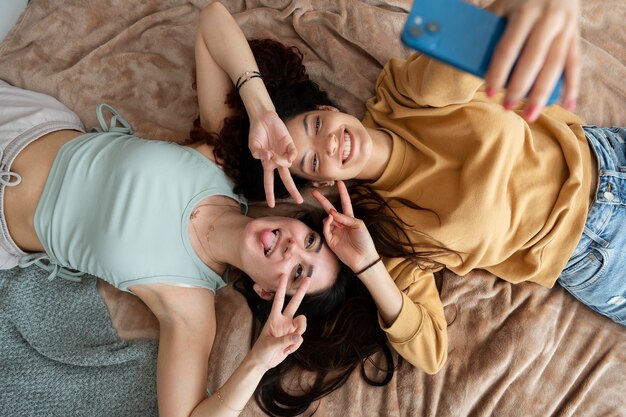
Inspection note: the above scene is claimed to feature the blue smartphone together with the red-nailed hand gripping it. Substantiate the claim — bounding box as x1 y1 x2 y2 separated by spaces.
402 0 577 121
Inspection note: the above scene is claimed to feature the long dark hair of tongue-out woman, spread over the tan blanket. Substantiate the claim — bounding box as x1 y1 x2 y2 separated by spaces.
234 210 400 416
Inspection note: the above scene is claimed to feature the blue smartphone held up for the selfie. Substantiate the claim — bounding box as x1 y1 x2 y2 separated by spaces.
402 0 563 104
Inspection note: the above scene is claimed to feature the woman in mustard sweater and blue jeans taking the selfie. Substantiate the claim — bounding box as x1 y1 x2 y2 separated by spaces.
194 0 626 404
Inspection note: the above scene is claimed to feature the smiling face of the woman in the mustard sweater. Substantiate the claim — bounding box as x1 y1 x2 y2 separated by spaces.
285 106 372 181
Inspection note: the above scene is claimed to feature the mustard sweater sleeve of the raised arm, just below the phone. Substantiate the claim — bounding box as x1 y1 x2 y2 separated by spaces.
376 53 483 108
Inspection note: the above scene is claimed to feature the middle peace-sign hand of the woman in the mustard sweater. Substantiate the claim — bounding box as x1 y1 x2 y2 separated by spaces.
313 181 378 271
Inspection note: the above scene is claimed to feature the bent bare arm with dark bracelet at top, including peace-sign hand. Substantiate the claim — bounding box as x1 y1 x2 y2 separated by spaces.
195 2 303 207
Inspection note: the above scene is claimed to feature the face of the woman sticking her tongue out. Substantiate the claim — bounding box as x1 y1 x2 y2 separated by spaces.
242 217 339 295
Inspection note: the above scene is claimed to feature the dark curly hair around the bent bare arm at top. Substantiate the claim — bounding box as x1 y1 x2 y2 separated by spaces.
190 39 336 201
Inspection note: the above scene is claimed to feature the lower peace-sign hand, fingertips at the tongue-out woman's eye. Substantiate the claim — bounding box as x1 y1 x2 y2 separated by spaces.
250 275 310 369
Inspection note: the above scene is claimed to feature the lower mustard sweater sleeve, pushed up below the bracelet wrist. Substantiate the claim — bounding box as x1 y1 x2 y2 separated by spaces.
379 258 448 374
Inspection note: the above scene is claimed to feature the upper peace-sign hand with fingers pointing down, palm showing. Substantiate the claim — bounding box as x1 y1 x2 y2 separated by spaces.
248 111 304 207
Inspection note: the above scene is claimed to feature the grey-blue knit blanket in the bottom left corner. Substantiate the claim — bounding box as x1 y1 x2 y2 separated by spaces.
0 267 158 417
